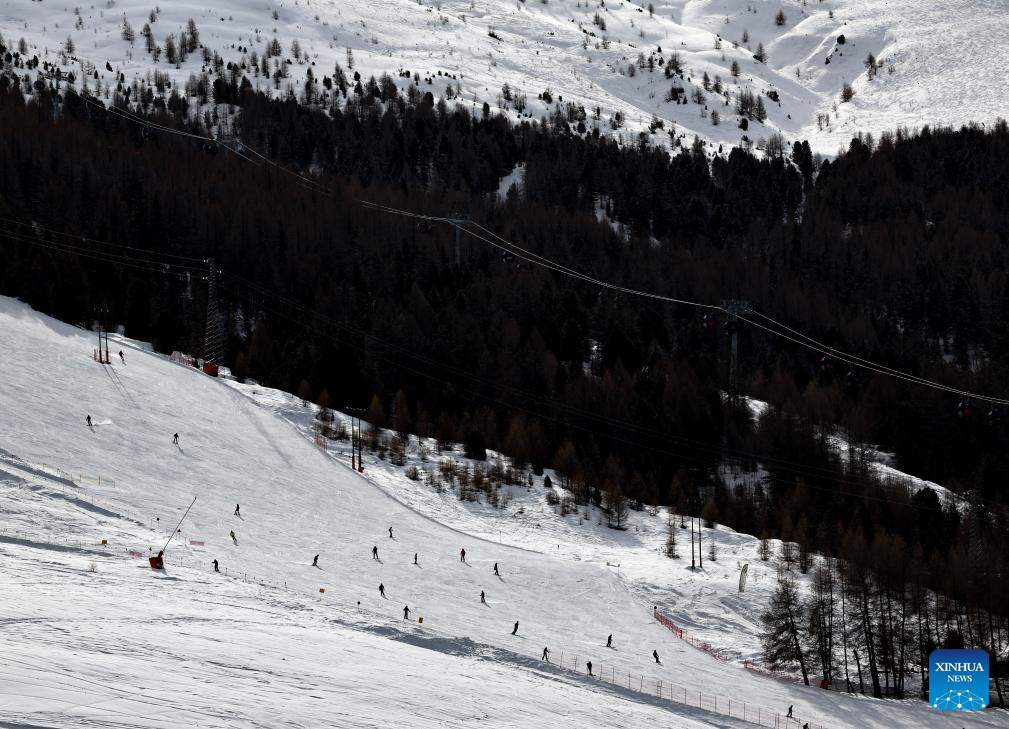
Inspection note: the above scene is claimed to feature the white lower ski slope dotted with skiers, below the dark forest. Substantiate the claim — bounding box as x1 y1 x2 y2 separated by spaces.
0 299 1007 729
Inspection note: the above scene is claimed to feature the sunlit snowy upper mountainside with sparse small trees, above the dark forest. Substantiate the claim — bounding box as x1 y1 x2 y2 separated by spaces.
0 0 1009 153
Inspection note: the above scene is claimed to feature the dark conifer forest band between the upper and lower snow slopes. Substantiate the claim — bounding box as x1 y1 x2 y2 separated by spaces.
0 76 1009 700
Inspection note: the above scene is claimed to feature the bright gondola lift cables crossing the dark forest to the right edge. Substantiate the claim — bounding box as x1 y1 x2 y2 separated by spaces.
363 201 1009 405
